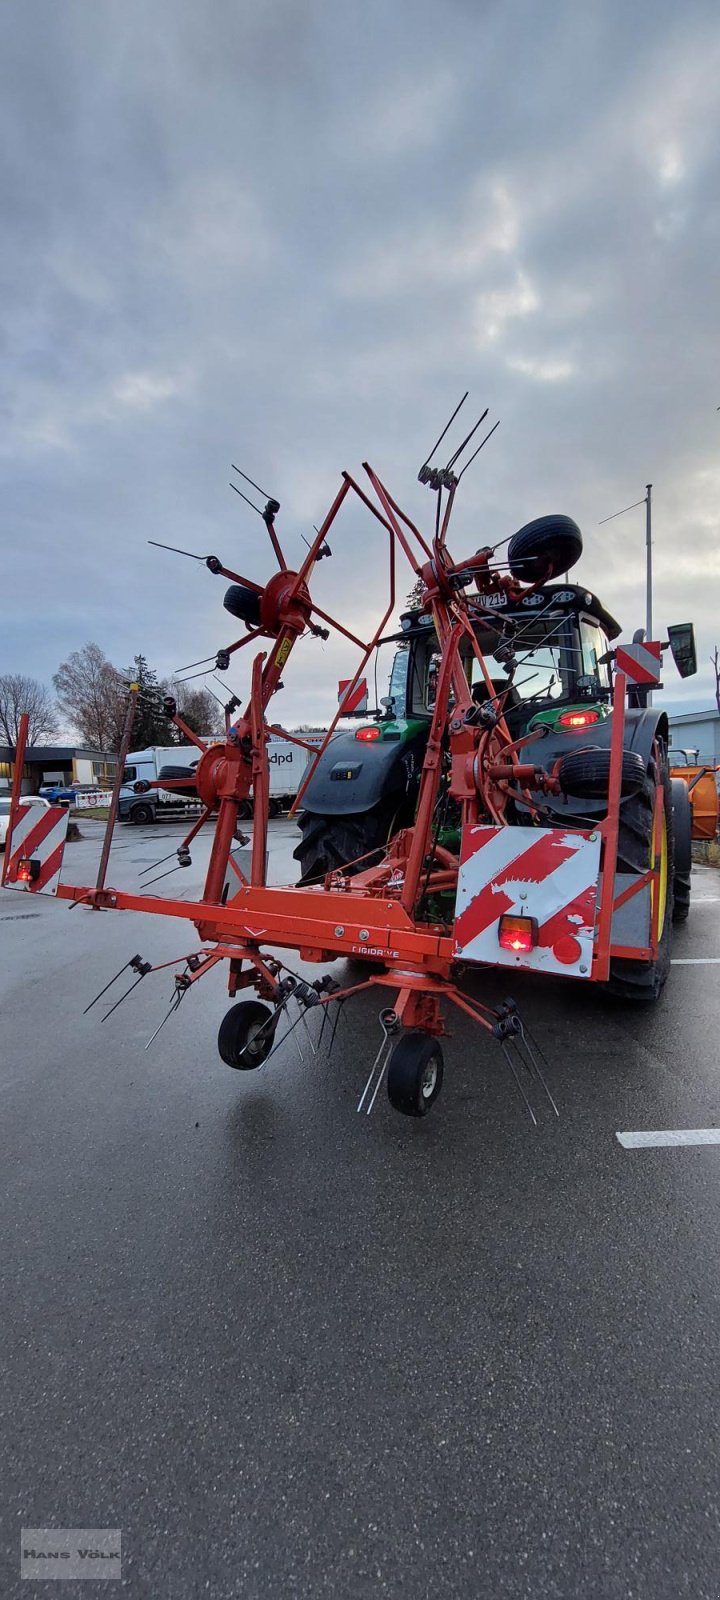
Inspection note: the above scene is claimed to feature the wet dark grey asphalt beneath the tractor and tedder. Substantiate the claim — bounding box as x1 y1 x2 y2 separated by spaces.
0 822 720 1600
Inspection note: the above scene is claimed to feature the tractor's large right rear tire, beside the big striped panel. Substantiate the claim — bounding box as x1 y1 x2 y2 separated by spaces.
608 752 674 1000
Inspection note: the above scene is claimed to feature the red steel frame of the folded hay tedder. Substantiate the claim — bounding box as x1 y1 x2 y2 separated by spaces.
35 464 662 1032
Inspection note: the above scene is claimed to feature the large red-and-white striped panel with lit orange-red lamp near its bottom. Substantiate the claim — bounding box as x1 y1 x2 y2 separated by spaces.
454 826 600 978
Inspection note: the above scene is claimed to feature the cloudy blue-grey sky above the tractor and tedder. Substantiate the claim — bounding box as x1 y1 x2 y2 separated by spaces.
0 0 720 732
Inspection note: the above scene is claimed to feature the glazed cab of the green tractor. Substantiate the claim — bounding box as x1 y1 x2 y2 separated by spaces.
386 584 621 738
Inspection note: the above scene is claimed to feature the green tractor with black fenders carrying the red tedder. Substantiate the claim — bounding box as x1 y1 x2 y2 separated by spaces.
294 569 691 998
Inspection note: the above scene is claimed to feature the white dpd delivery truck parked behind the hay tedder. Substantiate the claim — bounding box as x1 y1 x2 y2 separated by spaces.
118 731 323 824
